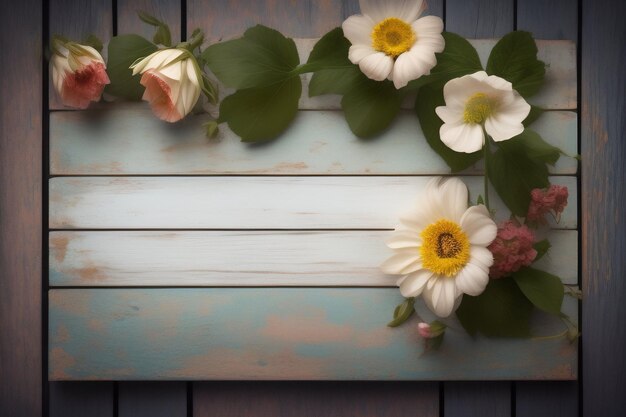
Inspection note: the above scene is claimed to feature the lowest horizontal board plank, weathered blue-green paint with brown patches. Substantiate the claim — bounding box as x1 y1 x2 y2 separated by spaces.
48 288 577 380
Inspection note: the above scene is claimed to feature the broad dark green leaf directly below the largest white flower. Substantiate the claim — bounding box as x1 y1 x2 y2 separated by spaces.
456 278 532 337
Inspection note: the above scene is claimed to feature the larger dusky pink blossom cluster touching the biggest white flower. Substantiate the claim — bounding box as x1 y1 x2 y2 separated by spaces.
488 220 537 278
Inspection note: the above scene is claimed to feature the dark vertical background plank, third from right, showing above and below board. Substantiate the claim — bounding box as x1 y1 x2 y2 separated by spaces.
444 0 514 417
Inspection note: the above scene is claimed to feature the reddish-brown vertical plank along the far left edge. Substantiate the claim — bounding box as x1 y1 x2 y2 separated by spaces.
0 0 43 417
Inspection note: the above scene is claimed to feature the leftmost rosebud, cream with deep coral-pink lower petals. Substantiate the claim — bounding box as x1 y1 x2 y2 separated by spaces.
50 42 110 109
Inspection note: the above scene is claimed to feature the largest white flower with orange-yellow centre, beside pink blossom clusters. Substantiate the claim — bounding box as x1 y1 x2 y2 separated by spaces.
381 178 498 317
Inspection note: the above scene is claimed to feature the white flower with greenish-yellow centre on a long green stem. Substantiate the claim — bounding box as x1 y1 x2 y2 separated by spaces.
435 71 530 153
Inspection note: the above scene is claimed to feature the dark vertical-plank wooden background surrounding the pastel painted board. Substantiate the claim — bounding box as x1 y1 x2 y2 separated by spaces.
0 0 626 417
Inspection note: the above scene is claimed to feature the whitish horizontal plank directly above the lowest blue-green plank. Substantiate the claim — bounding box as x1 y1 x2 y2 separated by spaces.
49 230 578 287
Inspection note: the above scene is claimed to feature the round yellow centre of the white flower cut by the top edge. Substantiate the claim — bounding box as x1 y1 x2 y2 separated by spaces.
372 17 416 58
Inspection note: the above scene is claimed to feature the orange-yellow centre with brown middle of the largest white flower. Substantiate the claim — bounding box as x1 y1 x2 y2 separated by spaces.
420 219 470 277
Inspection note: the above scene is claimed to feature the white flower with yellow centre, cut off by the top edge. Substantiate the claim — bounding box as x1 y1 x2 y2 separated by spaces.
342 0 445 88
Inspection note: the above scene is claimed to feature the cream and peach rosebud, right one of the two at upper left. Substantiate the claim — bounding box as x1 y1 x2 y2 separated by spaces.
131 48 202 123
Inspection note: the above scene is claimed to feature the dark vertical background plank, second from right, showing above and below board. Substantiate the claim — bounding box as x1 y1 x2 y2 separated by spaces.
515 0 578 417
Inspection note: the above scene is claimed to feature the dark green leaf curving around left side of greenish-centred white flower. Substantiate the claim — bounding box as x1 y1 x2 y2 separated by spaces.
415 85 482 172
